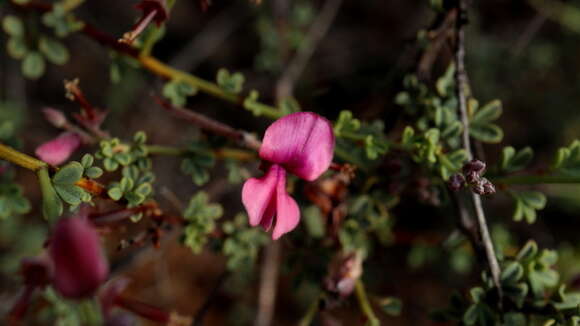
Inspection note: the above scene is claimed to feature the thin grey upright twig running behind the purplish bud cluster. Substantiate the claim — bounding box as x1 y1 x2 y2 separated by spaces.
455 0 502 302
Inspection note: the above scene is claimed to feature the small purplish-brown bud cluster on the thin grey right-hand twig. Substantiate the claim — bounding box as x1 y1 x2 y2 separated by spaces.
447 160 495 196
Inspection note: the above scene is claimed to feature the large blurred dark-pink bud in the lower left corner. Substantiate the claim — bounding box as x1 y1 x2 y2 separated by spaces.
49 213 109 299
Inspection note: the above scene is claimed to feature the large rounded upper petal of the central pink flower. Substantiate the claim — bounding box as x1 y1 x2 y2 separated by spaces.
260 112 334 181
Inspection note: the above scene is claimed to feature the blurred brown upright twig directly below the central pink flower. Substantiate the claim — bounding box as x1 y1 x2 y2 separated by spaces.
254 241 282 326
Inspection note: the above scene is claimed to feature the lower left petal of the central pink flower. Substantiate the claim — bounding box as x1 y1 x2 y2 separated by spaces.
242 164 286 229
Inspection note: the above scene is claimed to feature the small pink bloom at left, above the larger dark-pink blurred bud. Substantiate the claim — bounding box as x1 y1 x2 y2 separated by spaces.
35 132 81 165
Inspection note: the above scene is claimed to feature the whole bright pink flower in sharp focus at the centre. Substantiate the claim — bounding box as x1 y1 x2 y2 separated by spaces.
242 112 334 240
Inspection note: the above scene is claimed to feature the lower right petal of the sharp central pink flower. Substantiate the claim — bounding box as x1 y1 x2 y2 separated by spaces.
272 174 300 240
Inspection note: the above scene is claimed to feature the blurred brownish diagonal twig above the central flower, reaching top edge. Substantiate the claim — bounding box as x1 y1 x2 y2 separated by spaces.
276 0 342 99
